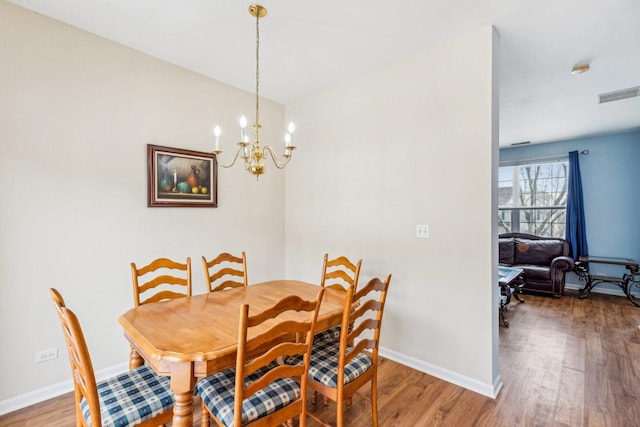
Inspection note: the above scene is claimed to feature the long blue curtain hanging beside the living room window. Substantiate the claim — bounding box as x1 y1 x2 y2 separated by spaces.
565 151 589 261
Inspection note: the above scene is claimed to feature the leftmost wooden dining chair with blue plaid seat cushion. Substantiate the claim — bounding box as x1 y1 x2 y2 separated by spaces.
50 288 174 427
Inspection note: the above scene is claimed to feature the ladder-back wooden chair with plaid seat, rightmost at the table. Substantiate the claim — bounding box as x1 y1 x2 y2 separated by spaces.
309 275 391 427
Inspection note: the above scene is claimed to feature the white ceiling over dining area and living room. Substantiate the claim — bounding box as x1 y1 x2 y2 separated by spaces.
9 0 640 146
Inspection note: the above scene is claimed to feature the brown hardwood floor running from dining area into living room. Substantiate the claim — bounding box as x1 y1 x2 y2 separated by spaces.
0 291 640 427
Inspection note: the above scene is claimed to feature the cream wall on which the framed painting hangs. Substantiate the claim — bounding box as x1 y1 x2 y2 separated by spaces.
0 2 285 402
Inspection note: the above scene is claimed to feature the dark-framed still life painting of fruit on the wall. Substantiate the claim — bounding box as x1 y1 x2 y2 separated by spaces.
147 144 218 208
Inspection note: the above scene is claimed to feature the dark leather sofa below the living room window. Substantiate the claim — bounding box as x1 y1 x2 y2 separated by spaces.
498 233 574 297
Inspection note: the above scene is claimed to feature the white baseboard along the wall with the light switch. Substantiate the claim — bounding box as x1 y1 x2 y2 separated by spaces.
379 347 502 399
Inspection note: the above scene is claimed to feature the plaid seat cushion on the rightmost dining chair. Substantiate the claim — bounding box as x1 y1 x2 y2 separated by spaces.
285 340 373 388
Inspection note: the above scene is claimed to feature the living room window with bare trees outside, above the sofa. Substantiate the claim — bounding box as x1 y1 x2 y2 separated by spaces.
498 160 569 238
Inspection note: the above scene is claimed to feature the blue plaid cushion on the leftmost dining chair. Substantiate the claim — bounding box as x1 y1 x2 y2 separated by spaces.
80 365 173 426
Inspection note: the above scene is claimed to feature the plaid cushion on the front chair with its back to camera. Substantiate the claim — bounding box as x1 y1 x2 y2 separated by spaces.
196 363 300 427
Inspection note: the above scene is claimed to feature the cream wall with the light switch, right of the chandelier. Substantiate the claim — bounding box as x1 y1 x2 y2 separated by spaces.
286 27 499 395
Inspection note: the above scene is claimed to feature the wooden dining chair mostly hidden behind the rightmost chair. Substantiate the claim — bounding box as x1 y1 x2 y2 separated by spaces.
315 254 362 342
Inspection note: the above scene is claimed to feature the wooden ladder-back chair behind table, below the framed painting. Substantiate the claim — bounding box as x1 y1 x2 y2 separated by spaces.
131 257 191 307
